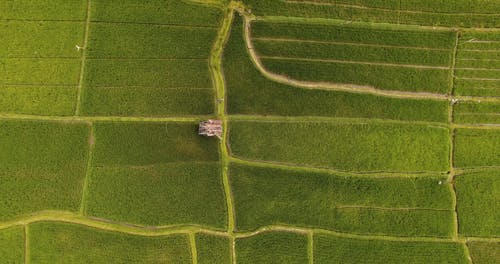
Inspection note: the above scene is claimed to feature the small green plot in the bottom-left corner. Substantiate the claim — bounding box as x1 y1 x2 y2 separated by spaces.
0 226 25 264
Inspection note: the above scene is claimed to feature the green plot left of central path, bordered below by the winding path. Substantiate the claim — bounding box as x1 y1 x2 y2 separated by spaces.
86 163 227 229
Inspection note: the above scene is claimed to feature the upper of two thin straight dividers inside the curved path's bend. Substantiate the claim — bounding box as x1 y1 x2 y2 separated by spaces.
252 37 450 51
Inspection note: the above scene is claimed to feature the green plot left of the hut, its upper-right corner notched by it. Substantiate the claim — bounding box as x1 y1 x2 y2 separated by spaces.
93 122 219 167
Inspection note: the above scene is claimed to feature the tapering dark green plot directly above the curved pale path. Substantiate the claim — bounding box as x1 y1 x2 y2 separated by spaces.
261 58 450 94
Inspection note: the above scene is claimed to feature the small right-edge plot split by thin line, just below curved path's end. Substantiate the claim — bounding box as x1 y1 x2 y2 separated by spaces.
453 101 500 124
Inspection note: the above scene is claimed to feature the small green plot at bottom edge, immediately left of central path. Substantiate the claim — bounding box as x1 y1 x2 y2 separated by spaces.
196 233 231 264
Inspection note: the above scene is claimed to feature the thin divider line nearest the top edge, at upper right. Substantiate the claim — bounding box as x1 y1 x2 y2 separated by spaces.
284 0 498 16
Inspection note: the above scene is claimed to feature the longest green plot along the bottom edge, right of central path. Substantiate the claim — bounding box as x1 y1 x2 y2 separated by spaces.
313 234 468 264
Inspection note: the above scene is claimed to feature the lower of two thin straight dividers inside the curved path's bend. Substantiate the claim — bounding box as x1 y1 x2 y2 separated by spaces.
257 55 450 70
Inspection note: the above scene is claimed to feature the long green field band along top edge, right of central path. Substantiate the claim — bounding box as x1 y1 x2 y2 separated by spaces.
244 0 500 27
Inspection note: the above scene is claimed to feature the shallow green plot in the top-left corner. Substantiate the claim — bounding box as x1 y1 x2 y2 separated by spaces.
0 0 88 21
